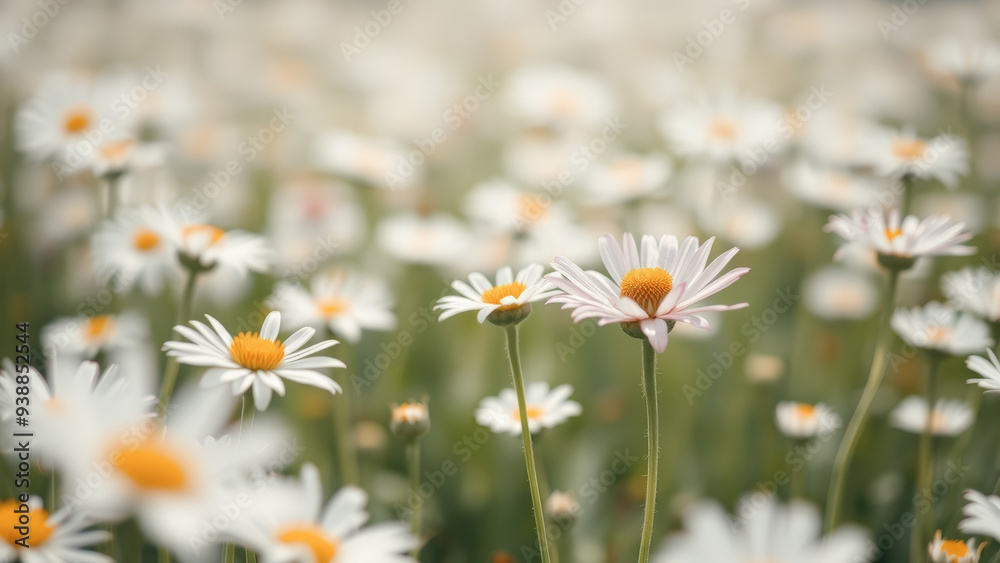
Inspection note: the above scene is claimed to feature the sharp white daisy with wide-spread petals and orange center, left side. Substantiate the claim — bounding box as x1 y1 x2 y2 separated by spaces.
163 311 346 410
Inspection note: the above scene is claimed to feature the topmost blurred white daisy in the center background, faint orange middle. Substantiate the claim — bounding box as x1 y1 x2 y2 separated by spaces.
503 65 617 129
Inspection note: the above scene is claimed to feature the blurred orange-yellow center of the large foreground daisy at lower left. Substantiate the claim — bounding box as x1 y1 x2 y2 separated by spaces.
109 439 188 491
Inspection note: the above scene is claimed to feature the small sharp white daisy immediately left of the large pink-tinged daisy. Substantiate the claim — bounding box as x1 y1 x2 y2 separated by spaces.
434 264 558 326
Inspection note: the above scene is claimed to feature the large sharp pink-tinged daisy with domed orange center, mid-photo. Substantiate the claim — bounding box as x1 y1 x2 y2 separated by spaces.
545 233 750 352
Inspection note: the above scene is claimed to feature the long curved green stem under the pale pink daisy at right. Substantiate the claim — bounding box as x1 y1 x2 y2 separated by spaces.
826 270 899 533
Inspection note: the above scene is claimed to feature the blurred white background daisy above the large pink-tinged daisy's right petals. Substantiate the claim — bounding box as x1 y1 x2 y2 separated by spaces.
659 92 784 163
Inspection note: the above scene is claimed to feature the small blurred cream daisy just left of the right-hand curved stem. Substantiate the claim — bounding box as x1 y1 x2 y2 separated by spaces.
802 266 879 320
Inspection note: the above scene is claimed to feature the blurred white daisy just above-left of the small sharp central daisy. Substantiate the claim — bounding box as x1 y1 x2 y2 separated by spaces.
375 213 470 266
